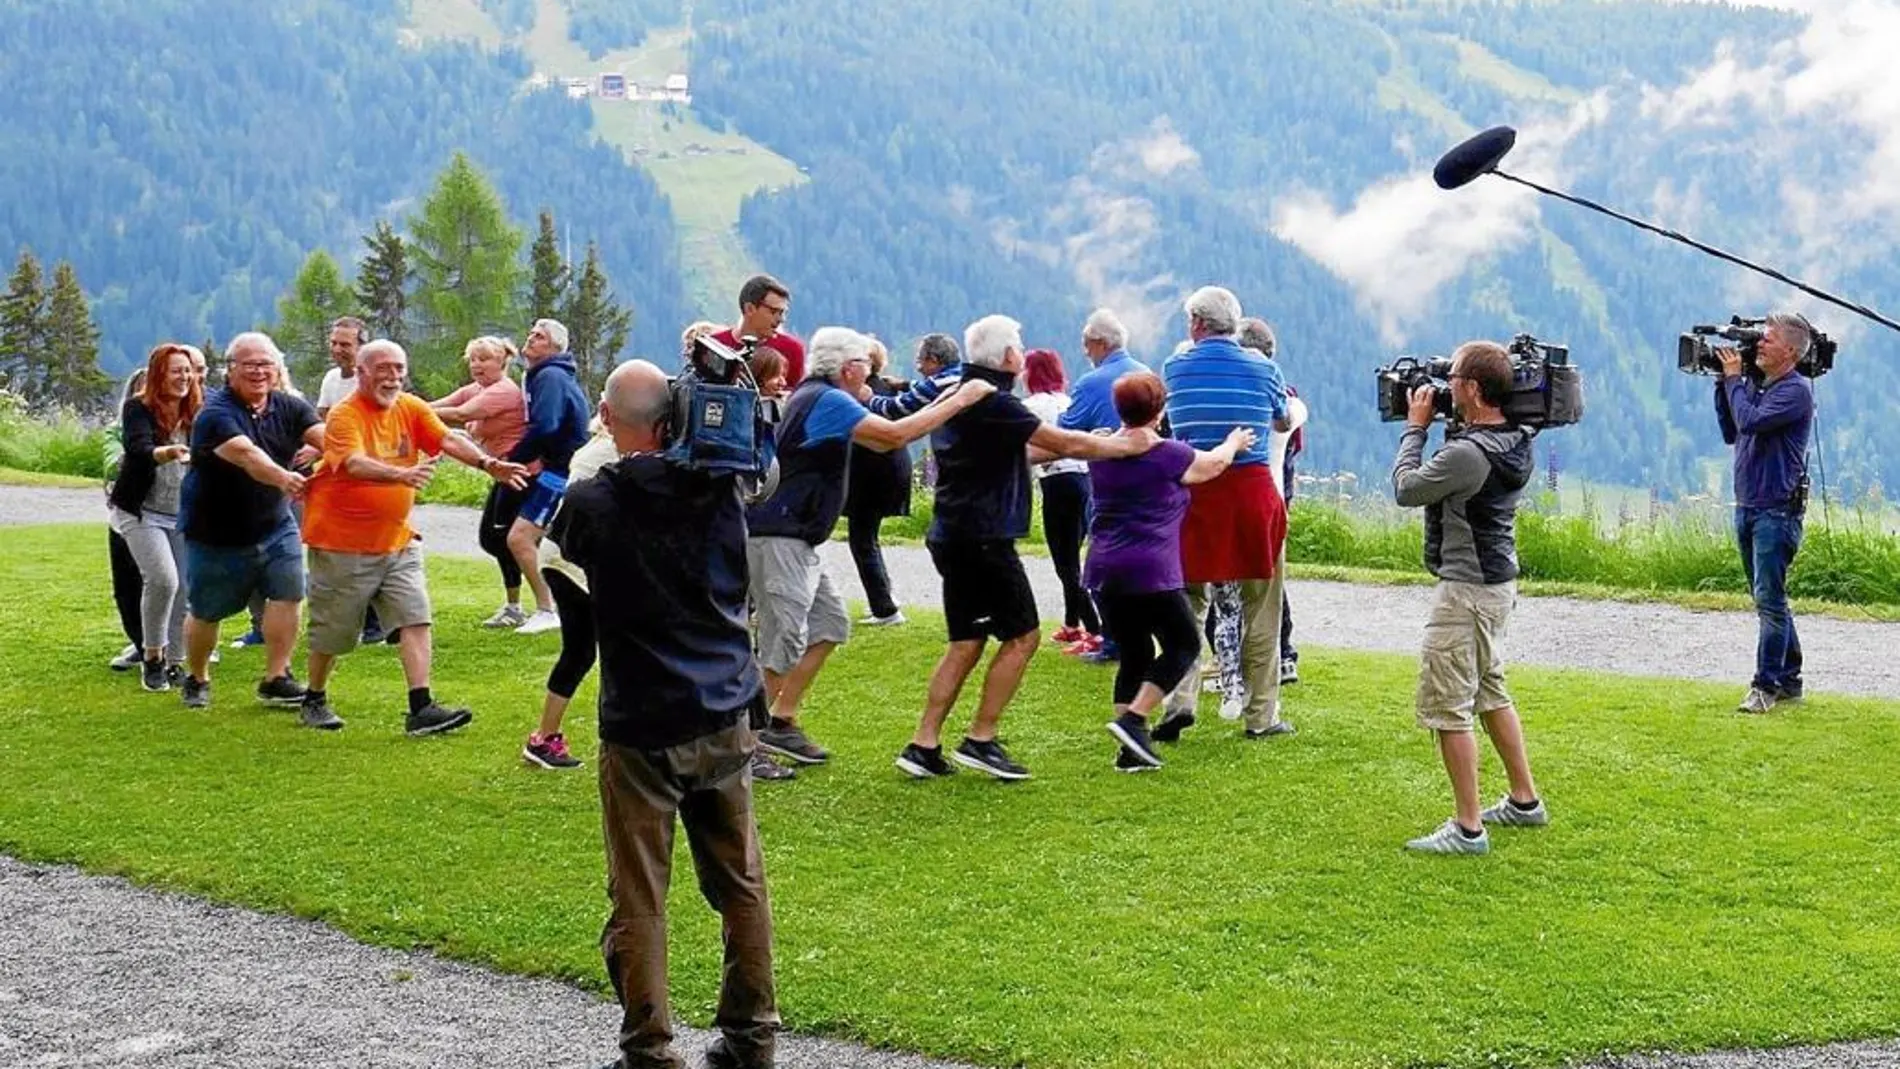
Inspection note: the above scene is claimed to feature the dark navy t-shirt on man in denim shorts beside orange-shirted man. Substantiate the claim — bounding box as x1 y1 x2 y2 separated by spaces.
179 387 321 545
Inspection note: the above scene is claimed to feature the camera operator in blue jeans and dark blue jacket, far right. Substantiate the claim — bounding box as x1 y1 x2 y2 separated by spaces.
1716 313 1815 712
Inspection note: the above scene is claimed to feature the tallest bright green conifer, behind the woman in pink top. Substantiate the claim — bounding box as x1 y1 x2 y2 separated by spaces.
409 152 526 397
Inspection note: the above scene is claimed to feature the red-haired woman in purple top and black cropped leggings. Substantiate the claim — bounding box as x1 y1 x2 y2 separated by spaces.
1083 372 1254 773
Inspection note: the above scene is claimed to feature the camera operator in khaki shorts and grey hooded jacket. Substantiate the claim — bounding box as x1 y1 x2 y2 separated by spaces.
1393 342 1550 854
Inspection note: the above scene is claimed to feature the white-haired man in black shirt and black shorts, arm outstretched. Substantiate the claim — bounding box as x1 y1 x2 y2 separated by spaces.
897 315 1157 780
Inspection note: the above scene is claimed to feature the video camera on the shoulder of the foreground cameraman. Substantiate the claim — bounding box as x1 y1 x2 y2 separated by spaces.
661 336 779 501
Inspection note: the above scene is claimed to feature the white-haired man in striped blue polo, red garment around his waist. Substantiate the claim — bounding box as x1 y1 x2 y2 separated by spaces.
1151 287 1294 742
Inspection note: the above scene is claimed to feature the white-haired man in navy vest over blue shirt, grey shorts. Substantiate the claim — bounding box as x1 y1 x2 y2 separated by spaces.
745 327 996 765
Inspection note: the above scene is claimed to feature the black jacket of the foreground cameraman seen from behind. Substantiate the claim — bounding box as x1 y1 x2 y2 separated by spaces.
547 454 764 750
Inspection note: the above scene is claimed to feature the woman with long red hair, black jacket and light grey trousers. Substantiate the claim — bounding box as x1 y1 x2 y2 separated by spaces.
110 342 205 691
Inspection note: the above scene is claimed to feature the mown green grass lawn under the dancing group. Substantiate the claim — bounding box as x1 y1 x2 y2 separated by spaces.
0 528 1900 1069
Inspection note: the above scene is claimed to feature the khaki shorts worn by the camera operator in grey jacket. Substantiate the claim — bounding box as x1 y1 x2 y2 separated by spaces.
1417 581 1518 731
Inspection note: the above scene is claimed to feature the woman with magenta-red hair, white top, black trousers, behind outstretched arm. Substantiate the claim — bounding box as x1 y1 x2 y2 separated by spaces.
1022 349 1102 653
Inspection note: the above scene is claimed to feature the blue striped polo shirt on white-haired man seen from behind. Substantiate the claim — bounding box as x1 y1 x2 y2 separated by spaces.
1161 338 1286 465
